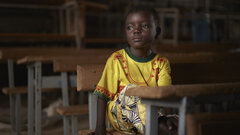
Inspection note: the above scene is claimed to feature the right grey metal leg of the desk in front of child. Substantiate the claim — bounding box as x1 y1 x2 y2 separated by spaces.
178 97 187 135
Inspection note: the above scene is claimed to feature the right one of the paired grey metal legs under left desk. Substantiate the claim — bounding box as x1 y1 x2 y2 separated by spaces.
35 62 42 135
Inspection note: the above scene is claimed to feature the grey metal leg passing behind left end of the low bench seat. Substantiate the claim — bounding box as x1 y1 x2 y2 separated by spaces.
61 72 70 135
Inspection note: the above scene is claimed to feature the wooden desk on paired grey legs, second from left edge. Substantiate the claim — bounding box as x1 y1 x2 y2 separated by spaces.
17 49 113 134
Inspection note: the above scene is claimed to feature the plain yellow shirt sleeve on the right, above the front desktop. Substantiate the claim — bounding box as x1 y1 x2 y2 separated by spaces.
157 58 172 86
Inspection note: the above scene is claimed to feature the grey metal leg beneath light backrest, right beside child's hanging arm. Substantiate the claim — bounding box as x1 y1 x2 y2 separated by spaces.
88 92 97 129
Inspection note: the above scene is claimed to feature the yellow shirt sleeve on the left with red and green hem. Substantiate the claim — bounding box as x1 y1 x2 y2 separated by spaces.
94 56 119 101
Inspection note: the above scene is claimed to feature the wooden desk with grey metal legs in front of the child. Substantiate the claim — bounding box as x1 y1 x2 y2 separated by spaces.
126 82 240 135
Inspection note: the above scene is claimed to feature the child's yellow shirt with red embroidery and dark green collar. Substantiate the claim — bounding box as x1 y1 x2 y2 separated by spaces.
94 48 171 101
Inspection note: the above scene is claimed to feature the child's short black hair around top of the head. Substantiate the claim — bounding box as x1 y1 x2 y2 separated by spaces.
124 6 161 38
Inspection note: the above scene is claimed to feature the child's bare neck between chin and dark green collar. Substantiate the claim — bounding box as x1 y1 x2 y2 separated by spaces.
130 47 152 58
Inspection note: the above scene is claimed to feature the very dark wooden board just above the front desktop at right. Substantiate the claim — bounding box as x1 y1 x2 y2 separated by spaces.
171 61 240 84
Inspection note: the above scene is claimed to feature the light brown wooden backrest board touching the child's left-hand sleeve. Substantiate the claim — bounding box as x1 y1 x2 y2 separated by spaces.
77 64 105 91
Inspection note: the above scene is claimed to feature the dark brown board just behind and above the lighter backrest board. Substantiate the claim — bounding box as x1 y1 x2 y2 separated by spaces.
53 54 109 72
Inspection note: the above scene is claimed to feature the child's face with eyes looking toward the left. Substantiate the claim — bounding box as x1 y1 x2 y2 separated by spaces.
125 11 156 49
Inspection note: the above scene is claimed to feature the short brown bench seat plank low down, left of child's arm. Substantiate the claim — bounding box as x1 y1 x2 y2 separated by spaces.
56 104 88 116
